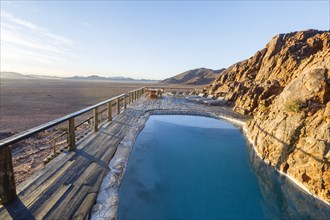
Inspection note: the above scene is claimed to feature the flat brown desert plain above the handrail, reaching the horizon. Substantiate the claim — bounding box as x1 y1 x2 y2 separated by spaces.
0 79 155 136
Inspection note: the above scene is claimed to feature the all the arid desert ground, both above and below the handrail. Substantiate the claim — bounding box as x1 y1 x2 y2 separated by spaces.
0 79 200 184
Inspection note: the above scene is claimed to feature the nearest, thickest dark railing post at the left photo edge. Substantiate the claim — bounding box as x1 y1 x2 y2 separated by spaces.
0 147 17 204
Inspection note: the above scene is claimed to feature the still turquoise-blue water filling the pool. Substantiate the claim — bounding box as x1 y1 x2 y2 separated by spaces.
118 115 330 219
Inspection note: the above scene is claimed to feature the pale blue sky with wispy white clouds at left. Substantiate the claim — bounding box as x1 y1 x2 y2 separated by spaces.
1 0 330 79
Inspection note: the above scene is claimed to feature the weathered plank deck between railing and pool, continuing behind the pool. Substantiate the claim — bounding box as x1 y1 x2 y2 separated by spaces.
0 97 241 219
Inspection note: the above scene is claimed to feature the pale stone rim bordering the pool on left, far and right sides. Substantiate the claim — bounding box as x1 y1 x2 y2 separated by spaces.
91 109 330 219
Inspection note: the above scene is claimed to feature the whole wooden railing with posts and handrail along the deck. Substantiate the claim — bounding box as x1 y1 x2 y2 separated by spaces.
0 87 145 204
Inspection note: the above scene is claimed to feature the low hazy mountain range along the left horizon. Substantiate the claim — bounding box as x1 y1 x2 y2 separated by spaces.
0 72 158 82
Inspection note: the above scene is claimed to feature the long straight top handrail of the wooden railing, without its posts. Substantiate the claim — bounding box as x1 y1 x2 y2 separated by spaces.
0 87 145 149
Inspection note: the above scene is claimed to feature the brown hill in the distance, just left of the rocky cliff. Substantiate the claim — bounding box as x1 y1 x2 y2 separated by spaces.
161 68 225 85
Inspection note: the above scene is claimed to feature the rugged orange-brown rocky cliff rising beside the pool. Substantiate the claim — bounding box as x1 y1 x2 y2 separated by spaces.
204 30 330 203
